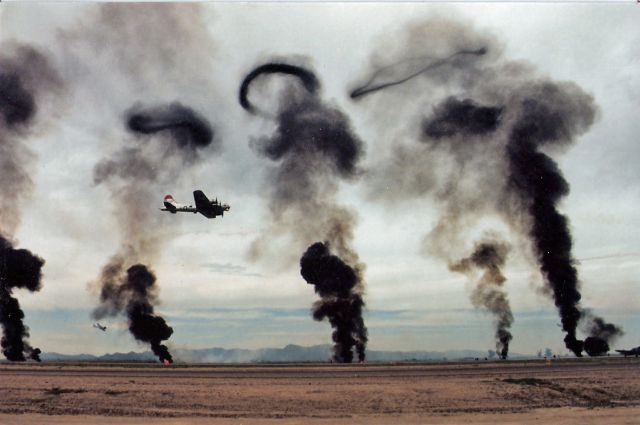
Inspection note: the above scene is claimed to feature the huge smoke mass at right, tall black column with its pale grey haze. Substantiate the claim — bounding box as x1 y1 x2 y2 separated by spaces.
358 20 616 356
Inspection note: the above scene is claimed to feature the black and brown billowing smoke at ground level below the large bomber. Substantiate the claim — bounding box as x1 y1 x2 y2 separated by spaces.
93 257 173 363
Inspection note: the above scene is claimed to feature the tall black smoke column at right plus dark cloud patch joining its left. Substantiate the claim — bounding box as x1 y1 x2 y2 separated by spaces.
423 91 622 356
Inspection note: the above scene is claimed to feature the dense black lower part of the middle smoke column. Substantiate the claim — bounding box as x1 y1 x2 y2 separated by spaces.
300 242 367 363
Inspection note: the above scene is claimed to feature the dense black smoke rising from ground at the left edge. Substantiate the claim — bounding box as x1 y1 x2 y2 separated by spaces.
0 236 44 361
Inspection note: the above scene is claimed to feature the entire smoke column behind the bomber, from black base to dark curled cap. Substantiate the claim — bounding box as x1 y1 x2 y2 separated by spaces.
93 103 217 363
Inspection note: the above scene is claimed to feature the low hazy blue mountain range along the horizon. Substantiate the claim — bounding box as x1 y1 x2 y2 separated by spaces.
41 344 524 363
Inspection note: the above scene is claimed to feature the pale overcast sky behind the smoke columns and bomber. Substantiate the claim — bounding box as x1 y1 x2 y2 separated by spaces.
0 2 640 354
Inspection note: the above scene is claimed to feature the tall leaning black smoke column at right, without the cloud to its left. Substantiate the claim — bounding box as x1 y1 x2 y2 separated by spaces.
506 82 620 356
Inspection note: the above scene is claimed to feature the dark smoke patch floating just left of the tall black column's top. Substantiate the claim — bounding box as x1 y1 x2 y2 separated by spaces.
422 97 502 139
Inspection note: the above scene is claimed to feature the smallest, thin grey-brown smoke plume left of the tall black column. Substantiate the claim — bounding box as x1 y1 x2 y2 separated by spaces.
449 236 513 359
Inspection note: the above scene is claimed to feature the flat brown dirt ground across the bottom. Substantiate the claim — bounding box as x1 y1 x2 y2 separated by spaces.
0 356 640 425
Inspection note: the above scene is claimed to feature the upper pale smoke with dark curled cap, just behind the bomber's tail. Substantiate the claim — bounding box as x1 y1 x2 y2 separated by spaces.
93 102 218 256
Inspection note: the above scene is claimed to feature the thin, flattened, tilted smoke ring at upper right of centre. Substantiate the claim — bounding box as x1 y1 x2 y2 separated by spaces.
349 47 487 99
